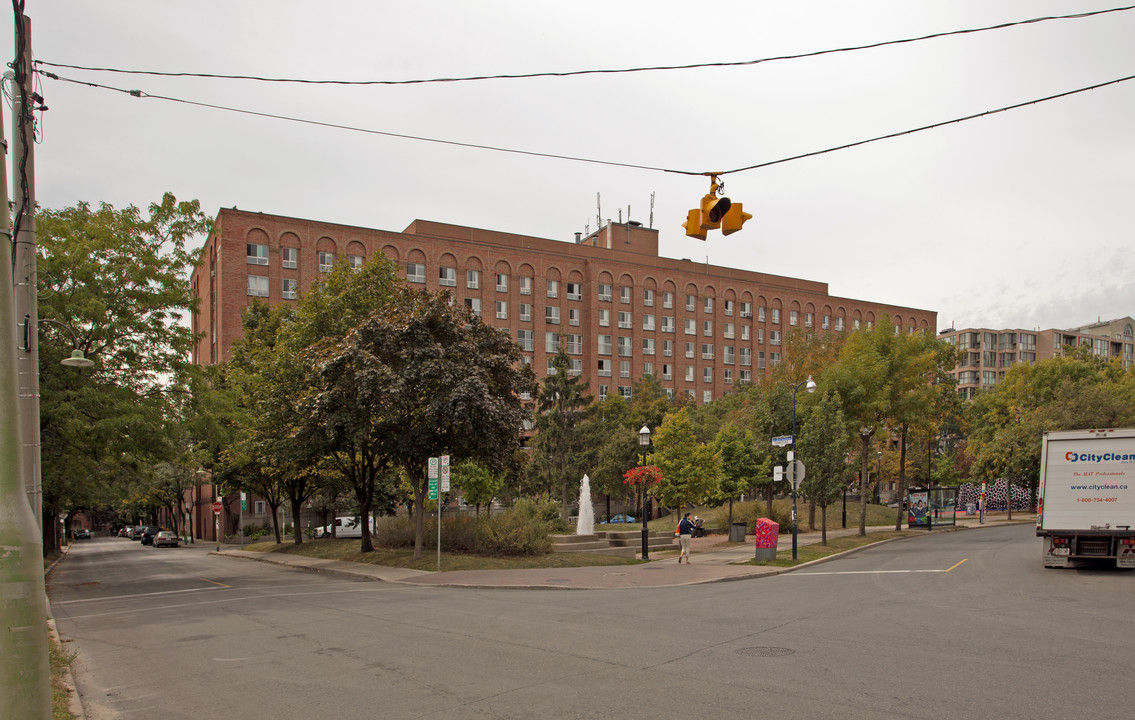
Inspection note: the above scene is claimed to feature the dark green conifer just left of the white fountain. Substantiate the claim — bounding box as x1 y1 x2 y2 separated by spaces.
532 346 591 520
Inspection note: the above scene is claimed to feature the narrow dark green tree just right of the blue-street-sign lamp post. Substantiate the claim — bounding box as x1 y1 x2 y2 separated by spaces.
799 392 851 545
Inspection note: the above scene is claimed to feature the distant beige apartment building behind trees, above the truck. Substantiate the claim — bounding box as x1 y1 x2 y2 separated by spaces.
939 317 1135 399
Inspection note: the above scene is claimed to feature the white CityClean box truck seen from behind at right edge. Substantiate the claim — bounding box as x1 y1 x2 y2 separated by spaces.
1036 428 1135 568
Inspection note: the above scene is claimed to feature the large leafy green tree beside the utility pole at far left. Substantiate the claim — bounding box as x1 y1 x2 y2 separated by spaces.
36 193 209 552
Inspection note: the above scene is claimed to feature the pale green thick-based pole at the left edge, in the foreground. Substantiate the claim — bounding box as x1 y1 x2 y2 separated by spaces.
0 11 51 720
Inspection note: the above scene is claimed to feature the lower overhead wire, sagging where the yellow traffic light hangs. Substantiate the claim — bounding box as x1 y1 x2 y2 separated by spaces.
36 70 1135 175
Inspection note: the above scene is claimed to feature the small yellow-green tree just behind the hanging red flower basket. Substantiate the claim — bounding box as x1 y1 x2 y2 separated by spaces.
653 407 722 513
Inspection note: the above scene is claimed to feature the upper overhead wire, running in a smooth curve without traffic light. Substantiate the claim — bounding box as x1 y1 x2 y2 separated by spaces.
35 6 1135 85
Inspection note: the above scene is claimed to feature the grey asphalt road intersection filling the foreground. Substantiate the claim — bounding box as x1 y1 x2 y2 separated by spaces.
49 525 1135 720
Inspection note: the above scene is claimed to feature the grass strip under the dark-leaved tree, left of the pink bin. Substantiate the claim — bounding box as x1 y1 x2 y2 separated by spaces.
244 538 641 572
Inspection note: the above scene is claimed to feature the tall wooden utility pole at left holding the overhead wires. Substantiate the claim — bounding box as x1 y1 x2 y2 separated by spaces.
6 9 41 533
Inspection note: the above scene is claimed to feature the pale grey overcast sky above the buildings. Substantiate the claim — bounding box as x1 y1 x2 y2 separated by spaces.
0 0 1135 328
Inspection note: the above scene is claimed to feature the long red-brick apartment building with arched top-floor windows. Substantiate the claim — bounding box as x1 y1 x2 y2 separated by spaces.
191 209 936 404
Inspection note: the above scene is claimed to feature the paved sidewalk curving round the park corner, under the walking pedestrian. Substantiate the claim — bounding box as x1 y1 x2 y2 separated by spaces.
210 512 1036 589
